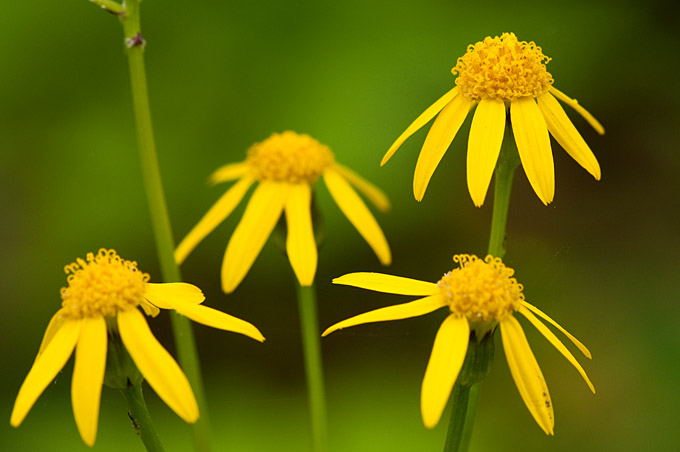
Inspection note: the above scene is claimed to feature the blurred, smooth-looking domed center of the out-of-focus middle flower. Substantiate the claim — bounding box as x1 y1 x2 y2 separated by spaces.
246 131 333 184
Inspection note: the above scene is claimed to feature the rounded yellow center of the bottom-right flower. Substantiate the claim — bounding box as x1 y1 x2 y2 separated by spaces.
437 254 524 323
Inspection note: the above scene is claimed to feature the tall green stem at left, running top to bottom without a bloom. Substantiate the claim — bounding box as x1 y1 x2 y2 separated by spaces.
121 0 210 452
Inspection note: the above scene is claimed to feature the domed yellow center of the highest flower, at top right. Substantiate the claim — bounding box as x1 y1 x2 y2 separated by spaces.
451 33 553 102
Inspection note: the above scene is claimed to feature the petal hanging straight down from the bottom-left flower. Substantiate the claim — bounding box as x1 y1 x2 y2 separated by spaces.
71 317 107 446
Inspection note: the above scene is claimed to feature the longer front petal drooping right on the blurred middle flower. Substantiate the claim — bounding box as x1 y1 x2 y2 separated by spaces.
323 168 392 265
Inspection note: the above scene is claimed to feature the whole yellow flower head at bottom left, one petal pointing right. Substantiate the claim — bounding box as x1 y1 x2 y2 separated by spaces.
10 249 264 446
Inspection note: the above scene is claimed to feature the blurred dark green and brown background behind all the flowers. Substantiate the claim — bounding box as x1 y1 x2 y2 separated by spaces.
0 0 680 452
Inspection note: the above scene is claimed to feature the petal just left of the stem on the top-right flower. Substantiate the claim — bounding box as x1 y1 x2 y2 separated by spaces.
467 100 505 207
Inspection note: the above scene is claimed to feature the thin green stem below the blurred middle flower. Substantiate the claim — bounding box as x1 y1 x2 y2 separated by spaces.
297 285 328 452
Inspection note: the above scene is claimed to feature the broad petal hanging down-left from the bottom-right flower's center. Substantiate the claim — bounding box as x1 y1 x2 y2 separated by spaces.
420 314 470 428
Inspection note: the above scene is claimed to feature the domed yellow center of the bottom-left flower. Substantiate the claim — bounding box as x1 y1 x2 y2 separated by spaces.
61 249 149 318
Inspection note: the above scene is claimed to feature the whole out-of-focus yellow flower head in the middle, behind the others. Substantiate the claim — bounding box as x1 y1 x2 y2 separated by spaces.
175 131 392 293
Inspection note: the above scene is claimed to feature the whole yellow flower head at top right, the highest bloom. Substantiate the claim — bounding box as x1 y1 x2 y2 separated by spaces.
381 33 604 207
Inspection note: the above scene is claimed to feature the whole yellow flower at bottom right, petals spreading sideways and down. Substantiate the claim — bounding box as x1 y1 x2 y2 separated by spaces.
323 254 595 435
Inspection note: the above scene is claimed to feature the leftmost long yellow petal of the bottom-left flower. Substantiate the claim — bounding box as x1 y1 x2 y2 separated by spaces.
9 319 81 427
